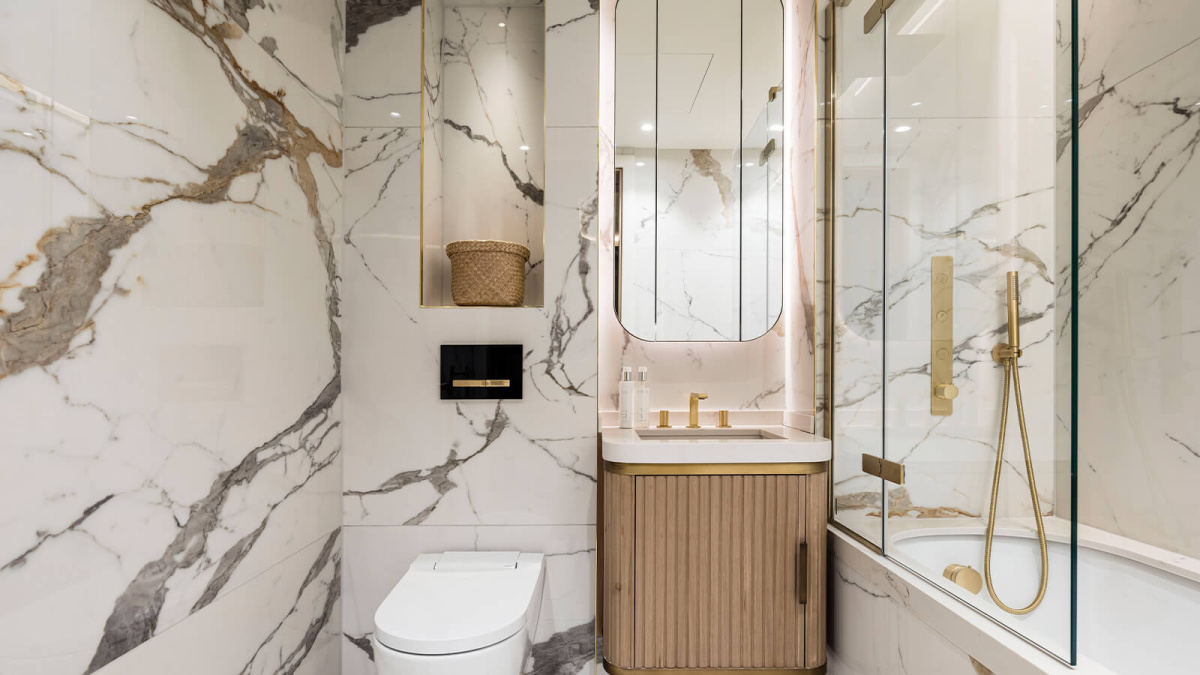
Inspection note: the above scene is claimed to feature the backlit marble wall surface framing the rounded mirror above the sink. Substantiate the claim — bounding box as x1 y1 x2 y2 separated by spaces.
598 0 816 429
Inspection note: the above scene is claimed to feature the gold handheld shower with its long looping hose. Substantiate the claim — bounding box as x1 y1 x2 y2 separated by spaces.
983 271 1050 615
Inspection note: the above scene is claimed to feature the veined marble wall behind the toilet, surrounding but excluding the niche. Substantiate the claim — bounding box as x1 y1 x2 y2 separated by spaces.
342 0 598 675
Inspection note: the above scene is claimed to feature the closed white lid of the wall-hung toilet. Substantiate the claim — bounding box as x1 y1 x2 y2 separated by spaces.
376 552 542 655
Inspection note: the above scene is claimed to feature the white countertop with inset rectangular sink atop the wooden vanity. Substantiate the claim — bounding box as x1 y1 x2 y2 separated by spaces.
600 425 830 464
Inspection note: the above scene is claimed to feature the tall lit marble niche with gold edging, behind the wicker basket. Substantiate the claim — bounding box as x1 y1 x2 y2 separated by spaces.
421 0 546 307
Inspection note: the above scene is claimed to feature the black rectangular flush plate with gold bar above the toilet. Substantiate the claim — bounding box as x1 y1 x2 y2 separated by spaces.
442 345 524 401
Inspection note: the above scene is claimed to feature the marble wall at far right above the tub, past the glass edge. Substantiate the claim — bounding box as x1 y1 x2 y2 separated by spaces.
1063 0 1200 557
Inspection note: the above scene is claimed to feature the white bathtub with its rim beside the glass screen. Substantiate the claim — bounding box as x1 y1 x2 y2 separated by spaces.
835 519 1200 675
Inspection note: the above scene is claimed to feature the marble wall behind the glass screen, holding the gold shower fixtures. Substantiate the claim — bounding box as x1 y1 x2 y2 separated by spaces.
832 0 1058 528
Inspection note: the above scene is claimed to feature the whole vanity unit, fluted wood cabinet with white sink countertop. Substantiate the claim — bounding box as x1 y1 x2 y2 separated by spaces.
601 426 829 675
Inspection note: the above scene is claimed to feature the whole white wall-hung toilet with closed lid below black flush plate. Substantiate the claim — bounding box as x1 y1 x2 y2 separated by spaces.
373 551 545 675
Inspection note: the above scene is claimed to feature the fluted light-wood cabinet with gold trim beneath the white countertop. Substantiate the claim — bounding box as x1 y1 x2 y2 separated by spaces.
604 471 827 671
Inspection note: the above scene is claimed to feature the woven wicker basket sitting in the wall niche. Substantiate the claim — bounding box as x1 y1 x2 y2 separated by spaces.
446 239 529 307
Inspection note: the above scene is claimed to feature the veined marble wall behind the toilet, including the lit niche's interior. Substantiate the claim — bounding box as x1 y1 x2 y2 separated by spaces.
341 0 599 675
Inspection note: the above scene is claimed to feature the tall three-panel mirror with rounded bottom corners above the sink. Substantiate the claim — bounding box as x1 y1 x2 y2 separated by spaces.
613 0 785 341
